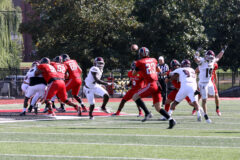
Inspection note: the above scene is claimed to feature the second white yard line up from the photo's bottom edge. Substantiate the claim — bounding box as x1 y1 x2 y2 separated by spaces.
0 141 240 149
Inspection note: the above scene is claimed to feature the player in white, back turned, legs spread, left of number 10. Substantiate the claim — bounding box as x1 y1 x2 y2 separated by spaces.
169 59 203 121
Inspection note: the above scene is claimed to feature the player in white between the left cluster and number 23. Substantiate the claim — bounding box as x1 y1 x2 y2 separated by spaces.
83 57 113 119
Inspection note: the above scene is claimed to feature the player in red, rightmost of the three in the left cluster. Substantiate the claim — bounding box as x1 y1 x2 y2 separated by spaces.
61 54 87 112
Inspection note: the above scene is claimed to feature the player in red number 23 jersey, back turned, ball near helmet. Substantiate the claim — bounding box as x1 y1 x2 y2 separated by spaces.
132 47 176 129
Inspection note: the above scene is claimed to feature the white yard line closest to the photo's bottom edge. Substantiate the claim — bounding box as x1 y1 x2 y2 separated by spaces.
0 154 178 160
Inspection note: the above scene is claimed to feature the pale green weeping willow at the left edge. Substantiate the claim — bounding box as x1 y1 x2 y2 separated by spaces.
0 0 22 68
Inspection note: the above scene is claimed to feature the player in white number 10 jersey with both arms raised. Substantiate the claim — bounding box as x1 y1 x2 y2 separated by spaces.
194 46 227 122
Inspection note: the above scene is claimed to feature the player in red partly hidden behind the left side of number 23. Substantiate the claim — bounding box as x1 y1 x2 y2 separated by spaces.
113 62 144 116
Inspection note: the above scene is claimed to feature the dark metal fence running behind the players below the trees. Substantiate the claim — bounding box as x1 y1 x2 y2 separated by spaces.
0 68 240 99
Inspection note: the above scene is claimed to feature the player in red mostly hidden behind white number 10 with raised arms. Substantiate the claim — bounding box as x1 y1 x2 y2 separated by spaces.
211 63 222 116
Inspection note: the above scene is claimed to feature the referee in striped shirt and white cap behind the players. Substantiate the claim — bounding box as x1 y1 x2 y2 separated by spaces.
158 56 169 106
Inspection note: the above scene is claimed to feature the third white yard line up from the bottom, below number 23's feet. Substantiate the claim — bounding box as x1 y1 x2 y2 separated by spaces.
0 132 240 139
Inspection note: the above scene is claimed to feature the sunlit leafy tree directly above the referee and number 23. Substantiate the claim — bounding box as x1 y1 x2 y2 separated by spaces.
133 0 208 61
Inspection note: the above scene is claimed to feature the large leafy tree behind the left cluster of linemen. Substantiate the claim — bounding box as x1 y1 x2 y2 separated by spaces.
21 0 138 76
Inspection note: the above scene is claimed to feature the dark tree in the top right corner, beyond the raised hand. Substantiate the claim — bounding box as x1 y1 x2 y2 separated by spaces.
204 0 240 72
